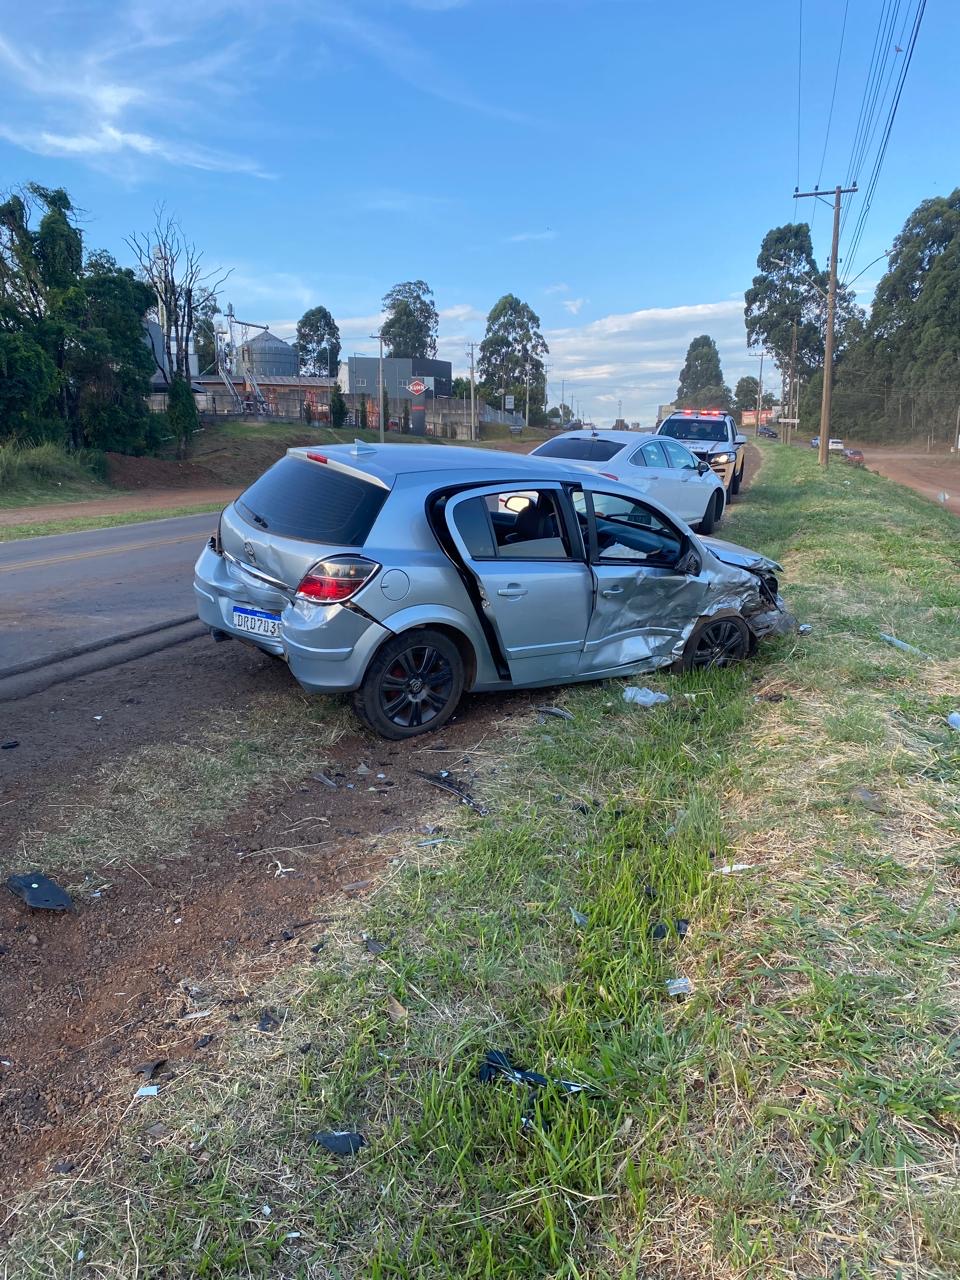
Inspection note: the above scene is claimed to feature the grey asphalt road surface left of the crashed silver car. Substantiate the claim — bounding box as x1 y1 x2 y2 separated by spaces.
0 513 216 680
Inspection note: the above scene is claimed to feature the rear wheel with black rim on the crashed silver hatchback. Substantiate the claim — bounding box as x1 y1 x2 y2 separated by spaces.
353 627 465 741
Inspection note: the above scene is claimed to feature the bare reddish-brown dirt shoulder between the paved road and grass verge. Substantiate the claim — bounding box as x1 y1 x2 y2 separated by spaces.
0 640 535 1190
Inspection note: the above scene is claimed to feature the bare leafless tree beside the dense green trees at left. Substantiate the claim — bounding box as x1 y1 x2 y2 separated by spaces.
127 205 230 383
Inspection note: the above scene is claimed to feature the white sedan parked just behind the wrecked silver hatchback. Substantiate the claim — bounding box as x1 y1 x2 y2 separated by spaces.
532 431 726 534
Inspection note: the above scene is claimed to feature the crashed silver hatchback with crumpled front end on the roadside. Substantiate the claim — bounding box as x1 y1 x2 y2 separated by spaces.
195 442 794 739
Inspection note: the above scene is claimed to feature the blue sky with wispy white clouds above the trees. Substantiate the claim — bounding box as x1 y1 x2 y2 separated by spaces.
0 0 960 424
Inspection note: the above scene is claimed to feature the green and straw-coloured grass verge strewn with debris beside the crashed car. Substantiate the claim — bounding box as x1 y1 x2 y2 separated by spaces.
8 445 960 1280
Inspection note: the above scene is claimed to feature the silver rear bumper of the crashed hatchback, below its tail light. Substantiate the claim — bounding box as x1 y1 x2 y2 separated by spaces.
193 547 392 694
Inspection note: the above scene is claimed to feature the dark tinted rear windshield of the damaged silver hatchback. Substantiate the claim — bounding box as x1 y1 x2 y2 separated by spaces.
237 454 388 547
